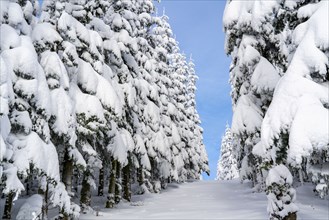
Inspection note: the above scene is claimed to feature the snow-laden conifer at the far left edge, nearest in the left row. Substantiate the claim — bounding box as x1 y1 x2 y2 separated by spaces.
1 1 70 218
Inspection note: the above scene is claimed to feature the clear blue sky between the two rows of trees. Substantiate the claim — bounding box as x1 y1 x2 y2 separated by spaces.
156 0 232 179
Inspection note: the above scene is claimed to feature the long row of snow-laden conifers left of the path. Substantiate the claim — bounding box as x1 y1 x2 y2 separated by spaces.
0 0 208 219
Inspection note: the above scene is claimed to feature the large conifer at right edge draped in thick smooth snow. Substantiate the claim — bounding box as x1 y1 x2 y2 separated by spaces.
262 1 329 202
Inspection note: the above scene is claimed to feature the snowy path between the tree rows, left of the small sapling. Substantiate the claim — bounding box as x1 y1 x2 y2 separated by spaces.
81 181 267 219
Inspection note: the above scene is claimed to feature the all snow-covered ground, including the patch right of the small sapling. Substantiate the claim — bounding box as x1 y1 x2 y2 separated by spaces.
80 180 329 220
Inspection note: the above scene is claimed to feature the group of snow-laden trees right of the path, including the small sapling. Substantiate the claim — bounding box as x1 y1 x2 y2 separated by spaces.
223 0 329 219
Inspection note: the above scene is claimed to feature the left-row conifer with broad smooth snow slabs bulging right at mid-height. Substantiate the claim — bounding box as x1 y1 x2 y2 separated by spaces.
42 2 122 213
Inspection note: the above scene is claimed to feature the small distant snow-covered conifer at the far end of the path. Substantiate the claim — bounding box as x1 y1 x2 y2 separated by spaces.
216 125 239 180
